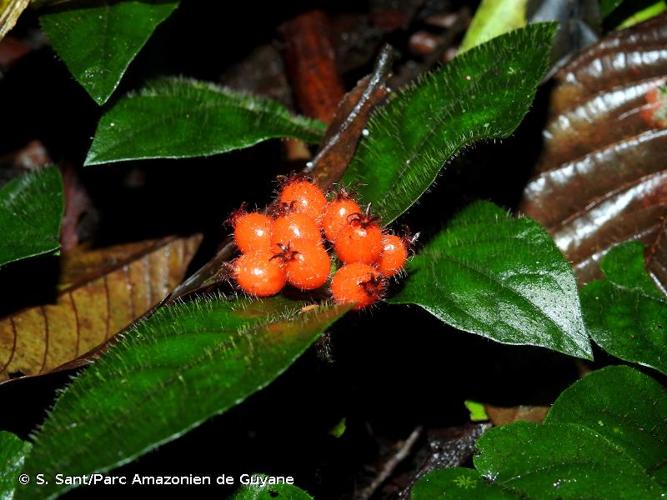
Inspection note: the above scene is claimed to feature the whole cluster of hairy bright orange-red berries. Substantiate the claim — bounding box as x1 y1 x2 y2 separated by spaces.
231 178 408 309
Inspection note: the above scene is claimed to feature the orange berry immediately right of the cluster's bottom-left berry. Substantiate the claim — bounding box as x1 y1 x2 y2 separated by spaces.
283 242 331 290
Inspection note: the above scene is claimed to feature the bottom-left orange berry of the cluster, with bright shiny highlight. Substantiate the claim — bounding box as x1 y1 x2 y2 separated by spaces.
233 251 287 297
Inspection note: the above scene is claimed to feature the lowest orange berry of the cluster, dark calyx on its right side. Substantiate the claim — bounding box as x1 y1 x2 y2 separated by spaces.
331 262 385 309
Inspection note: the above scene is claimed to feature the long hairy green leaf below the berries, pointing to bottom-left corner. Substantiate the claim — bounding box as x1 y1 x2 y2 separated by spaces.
20 297 346 499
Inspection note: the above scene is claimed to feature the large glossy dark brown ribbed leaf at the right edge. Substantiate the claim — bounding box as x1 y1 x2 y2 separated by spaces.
520 15 667 291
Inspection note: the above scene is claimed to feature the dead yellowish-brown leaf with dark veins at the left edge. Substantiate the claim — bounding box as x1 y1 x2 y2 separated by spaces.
0 236 201 381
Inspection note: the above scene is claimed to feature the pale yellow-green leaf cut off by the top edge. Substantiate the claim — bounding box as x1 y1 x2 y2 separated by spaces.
460 0 527 52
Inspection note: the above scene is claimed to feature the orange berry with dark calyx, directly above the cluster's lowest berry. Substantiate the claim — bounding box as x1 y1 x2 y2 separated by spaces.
334 213 382 264
